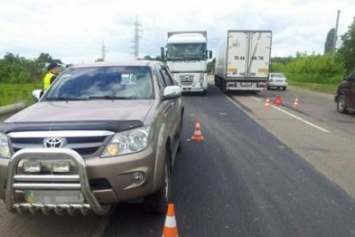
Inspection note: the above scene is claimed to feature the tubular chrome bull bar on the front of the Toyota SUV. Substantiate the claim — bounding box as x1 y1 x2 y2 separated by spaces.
5 148 110 215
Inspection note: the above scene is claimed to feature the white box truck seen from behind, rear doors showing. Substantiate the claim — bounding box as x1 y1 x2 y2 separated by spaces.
214 30 272 93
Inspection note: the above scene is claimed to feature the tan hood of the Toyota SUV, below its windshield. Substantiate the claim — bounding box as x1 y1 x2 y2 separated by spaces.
5 100 155 122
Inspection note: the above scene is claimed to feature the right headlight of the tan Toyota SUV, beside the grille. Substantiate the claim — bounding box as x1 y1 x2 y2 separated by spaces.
101 126 150 157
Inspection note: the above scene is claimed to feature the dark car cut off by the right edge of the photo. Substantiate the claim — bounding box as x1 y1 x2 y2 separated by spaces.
334 71 355 114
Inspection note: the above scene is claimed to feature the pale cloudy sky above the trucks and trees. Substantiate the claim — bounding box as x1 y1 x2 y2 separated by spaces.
0 0 355 64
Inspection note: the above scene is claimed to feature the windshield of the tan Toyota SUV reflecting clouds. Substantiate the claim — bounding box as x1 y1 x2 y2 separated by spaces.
44 66 153 101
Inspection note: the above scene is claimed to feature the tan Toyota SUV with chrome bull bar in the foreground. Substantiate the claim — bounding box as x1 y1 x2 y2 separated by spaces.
0 60 184 215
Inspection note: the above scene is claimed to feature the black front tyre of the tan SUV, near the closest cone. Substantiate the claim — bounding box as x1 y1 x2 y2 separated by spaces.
143 153 171 214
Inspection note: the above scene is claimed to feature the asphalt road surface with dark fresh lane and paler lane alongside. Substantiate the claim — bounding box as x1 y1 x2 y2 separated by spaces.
0 82 355 237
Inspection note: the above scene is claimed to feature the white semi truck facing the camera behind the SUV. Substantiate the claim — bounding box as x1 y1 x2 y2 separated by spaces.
161 31 212 95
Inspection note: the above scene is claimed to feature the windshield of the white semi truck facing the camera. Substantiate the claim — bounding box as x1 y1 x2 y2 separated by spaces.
167 43 206 60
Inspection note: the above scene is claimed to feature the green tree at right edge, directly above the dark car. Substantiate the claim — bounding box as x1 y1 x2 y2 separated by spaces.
336 22 355 73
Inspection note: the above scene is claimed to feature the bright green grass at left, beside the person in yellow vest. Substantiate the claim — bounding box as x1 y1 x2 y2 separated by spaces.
0 83 42 106
